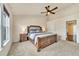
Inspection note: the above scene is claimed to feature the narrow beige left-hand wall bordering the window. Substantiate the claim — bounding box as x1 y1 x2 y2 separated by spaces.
0 4 12 56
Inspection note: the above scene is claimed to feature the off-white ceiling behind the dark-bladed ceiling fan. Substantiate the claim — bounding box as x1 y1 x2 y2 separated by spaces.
9 3 72 15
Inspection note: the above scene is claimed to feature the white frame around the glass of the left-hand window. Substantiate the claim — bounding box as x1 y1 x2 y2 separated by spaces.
0 4 10 51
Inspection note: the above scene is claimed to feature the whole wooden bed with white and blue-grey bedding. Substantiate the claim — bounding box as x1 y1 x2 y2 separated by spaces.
27 25 57 52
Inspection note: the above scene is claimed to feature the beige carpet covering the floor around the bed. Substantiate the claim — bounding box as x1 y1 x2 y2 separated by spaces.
8 40 79 56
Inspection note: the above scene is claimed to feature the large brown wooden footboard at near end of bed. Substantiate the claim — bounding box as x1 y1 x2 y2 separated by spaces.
36 34 57 51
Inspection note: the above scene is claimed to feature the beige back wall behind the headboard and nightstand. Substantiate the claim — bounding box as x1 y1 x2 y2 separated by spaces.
13 15 46 42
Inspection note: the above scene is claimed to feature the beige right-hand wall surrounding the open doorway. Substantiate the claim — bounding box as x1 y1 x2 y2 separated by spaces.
47 4 79 43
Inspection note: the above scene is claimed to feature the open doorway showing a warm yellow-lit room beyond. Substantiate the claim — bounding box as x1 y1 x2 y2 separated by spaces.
66 20 76 41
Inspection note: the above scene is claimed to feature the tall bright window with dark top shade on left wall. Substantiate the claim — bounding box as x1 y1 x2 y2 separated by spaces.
0 5 10 47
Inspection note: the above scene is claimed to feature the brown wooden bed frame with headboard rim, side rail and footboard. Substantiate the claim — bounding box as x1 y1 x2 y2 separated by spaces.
27 25 57 52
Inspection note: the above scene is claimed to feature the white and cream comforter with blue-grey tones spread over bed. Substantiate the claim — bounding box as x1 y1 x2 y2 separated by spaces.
28 32 53 44
